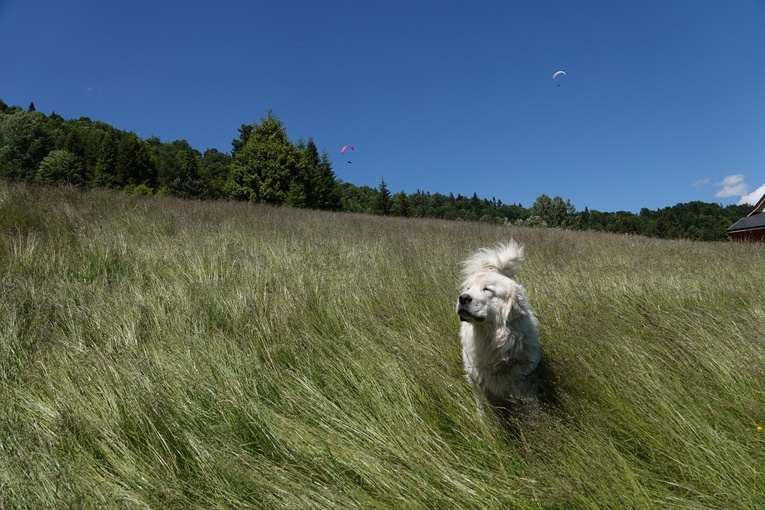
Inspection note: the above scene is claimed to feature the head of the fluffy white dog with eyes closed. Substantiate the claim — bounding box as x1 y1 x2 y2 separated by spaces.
457 271 527 328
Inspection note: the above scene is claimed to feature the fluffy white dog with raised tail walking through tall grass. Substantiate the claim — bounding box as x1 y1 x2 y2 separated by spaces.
457 239 542 412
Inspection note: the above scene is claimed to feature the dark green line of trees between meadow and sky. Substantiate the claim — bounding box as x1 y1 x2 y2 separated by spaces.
0 100 750 241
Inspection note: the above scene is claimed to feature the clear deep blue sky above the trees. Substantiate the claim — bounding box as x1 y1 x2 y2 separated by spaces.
0 0 765 212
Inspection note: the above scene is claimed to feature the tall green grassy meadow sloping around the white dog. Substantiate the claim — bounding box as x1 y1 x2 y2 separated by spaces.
0 184 765 509
